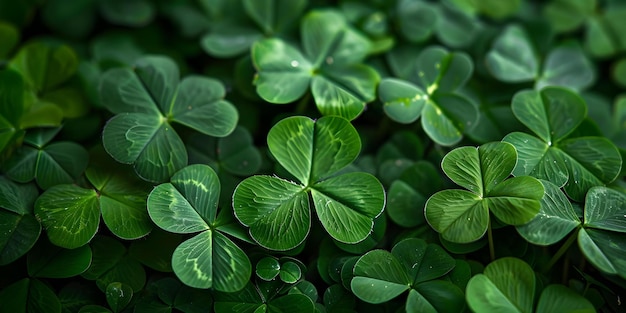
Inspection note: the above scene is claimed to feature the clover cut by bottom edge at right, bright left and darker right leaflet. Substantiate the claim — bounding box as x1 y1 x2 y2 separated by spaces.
465 257 595 313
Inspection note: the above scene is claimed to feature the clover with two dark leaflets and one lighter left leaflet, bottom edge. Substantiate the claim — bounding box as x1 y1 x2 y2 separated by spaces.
350 238 465 312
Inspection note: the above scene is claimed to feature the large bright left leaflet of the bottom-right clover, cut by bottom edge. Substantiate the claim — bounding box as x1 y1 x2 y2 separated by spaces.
466 257 535 313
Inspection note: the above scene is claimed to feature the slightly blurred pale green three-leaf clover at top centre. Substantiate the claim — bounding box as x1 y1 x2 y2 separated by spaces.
252 10 380 120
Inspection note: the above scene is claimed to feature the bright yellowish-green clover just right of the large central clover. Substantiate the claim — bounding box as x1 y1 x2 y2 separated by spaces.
424 142 544 243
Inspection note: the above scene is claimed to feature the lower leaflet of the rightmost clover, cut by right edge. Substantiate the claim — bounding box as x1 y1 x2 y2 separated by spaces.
578 228 626 279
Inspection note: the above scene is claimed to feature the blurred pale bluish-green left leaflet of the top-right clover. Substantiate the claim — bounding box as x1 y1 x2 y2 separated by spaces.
485 25 539 83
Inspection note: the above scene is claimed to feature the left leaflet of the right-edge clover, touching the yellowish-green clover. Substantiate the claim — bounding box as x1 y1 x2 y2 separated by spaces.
516 180 581 246
